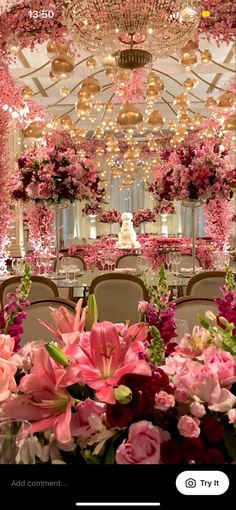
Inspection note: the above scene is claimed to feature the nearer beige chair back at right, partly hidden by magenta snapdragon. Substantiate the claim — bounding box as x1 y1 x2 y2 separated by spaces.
175 296 218 333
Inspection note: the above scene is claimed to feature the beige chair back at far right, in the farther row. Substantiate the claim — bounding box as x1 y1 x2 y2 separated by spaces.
186 271 236 299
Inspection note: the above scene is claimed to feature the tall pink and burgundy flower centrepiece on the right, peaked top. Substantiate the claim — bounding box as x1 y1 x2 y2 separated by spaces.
148 120 236 207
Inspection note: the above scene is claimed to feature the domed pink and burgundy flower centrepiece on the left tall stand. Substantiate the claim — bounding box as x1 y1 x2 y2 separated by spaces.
12 140 104 205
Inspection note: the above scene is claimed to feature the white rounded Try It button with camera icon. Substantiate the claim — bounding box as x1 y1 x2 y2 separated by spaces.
176 471 229 496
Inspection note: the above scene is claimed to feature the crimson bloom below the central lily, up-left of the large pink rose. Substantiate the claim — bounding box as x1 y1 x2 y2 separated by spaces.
71 398 105 438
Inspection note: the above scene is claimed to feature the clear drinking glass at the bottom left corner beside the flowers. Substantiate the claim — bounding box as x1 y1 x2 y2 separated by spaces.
0 420 35 464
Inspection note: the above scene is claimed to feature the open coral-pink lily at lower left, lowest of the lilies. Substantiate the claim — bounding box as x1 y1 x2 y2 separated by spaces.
4 348 78 443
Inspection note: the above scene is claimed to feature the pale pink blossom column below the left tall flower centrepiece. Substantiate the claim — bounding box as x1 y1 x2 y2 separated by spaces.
25 202 55 257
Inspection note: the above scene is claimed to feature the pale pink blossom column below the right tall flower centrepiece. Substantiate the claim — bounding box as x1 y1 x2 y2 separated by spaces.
204 199 232 251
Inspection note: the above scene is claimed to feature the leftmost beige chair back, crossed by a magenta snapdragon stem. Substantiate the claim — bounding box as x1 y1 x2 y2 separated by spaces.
0 276 59 307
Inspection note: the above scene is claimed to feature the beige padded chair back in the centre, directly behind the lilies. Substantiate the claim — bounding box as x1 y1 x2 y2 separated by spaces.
89 273 148 324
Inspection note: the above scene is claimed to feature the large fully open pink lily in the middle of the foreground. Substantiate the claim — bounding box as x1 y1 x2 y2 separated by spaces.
77 321 152 404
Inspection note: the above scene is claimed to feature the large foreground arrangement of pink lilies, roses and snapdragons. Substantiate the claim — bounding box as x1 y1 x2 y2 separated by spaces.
0 268 236 465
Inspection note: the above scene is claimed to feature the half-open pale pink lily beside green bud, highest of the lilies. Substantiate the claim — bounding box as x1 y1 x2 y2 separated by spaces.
39 299 87 347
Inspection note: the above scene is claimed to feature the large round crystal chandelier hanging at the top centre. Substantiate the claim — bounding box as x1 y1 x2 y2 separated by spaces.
64 0 200 65
